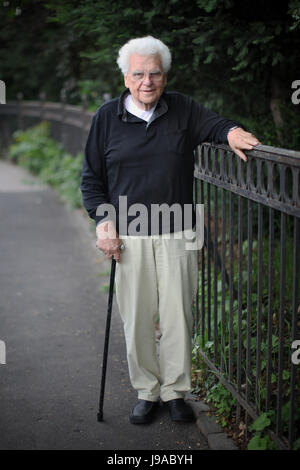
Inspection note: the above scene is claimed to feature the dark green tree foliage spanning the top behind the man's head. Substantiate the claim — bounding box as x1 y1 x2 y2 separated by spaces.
0 0 300 149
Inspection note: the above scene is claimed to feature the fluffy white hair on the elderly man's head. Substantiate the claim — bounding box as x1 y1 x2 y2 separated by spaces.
117 36 172 75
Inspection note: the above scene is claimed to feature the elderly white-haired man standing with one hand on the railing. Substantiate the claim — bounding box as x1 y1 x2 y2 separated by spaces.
81 36 259 424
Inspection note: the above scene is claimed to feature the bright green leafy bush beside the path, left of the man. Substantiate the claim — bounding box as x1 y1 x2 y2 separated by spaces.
8 122 83 207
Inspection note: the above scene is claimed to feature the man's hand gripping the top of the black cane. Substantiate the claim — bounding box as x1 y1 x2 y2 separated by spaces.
96 220 122 263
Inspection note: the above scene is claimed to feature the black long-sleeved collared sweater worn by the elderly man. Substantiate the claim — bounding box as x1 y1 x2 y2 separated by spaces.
81 89 242 235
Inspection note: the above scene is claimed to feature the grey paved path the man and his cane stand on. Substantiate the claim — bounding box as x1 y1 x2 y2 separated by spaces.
0 160 208 450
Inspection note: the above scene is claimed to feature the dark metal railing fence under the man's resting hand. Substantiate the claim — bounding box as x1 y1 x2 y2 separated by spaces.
195 144 300 448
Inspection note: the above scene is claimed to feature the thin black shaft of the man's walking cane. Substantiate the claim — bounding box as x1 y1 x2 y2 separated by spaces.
97 259 116 421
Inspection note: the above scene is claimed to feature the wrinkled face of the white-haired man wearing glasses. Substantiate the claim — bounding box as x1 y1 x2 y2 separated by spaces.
124 54 167 110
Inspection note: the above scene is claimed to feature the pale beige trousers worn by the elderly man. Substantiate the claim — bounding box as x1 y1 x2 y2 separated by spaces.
116 231 198 401
